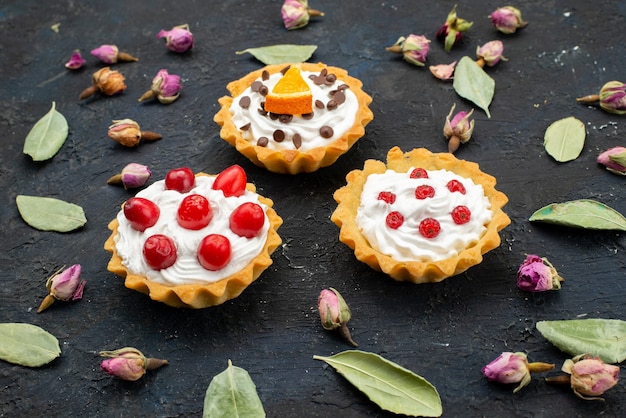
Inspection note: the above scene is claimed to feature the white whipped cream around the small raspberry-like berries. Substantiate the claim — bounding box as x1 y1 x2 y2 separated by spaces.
356 169 493 261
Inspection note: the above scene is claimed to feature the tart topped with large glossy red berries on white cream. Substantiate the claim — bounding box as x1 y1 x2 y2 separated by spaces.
104 165 282 308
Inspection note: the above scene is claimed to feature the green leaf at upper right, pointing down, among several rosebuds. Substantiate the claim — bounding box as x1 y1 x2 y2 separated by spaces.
453 57 496 118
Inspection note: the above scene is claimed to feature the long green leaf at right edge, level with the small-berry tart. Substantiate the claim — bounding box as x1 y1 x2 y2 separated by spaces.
528 199 626 231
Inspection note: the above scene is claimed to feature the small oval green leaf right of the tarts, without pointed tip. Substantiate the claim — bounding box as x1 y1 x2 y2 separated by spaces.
543 116 587 163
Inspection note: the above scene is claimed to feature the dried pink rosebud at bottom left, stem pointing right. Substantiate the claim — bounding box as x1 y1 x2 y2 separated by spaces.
100 347 168 382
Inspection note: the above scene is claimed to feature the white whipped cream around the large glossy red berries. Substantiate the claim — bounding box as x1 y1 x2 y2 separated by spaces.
115 176 270 286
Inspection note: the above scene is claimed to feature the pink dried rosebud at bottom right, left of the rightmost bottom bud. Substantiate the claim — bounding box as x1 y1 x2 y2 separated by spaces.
482 352 554 393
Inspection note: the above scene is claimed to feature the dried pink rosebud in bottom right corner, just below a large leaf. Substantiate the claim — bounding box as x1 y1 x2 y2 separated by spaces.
546 354 619 401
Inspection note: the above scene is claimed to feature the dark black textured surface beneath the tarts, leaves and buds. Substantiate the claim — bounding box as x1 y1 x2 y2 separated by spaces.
0 0 626 417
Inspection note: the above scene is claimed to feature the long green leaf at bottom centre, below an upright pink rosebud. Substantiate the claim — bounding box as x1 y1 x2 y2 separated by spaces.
313 350 443 417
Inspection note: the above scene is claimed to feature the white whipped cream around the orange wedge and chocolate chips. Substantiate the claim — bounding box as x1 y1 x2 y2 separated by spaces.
230 71 359 151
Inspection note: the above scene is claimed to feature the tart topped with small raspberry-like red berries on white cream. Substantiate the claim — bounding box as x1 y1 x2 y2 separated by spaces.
331 147 511 283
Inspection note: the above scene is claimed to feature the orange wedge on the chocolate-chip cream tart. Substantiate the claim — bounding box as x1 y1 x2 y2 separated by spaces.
265 67 313 115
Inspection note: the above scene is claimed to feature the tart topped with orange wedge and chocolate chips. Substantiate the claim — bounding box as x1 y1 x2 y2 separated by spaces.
214 63 374 174
